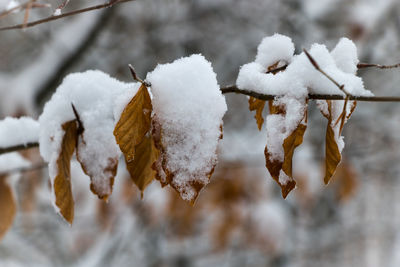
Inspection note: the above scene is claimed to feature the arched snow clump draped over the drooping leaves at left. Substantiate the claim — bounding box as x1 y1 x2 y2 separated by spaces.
39 70 138 205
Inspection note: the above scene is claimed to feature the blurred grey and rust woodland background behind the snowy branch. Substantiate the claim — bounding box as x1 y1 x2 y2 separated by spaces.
0 0 400 267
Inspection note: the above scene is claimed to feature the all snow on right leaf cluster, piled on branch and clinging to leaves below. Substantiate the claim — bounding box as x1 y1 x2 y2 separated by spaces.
237 34 372 165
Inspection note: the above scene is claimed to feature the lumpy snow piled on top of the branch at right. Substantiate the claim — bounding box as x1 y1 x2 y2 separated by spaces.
236 34 372 98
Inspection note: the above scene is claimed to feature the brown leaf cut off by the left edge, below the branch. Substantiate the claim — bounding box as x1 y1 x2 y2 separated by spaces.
0 176 16 240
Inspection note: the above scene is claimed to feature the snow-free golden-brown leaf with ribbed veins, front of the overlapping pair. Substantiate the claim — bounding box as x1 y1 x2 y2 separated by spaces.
114 84 153 162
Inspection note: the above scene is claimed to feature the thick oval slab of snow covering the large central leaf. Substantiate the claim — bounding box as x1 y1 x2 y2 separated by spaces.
147 55 227 200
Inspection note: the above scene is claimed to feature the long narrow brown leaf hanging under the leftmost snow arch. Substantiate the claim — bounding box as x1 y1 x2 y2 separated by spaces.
54 120 78 224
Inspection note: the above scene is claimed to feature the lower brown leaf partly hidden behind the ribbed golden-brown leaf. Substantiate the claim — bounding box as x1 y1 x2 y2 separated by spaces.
126 135 160 194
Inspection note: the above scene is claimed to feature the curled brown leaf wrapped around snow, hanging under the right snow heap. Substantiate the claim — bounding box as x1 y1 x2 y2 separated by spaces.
264 101 307 198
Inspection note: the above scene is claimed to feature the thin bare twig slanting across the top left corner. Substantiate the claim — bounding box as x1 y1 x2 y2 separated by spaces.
0 0 135 31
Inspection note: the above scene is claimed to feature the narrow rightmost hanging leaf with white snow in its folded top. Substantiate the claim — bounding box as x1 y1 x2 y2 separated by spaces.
320 100 357 184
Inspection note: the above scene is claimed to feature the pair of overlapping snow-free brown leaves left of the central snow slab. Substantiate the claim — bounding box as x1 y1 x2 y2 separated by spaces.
114 84 155 196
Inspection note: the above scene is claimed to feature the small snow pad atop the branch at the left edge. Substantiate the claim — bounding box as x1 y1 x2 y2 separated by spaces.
0 117 39 147
